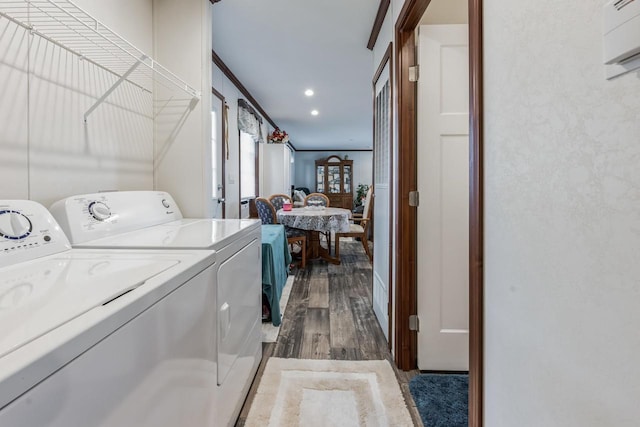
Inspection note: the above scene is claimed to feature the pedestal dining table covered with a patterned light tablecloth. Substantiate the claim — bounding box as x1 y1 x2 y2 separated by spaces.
276 206 351 264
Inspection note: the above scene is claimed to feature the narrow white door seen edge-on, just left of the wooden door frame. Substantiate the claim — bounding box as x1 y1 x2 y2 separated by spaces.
373 63 391 340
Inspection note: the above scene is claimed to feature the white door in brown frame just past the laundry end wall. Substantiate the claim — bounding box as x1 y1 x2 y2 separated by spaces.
211 95 224 218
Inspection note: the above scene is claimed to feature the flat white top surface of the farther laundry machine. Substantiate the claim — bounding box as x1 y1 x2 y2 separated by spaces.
74 219 261 250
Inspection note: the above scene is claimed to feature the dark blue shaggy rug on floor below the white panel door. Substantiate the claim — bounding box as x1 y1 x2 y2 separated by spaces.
409 374 469 427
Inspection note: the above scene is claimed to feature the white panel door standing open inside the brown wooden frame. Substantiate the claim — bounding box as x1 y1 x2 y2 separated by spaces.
417 24 469 370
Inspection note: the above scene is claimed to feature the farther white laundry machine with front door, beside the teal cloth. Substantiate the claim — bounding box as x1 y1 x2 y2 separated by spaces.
50 191 262 426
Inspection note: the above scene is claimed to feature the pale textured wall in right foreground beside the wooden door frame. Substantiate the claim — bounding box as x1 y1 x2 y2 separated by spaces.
484 0 640 427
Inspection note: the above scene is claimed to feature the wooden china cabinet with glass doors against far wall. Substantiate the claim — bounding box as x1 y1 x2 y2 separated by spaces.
316 156 353 210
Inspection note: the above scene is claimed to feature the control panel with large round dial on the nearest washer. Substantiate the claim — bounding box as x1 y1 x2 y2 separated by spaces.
0 200 71 268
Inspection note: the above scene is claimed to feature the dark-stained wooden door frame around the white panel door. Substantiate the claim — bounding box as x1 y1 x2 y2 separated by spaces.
395 0 484 427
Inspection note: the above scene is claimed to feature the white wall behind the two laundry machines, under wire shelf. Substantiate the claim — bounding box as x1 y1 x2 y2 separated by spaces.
0 0 153 205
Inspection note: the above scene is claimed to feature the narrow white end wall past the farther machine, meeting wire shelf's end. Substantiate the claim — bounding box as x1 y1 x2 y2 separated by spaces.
153 0 214 218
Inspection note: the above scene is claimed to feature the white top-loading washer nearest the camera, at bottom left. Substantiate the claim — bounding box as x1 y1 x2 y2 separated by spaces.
0 201 218 427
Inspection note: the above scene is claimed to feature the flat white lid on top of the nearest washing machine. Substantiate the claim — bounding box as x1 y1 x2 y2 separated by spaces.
0 251 180 357
